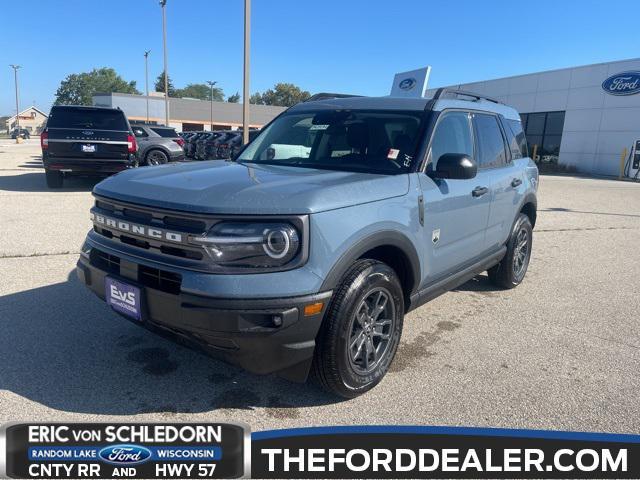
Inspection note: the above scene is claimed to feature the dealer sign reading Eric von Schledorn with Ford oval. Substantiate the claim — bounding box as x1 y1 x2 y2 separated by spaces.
0 423 250 479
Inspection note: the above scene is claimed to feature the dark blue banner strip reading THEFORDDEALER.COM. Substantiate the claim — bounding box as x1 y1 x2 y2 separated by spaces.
251 426 640 478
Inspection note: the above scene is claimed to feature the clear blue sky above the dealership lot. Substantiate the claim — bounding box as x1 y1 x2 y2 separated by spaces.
0 0 640 116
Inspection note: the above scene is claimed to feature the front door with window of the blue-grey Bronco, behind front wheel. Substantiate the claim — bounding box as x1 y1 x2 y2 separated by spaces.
419 110 491 284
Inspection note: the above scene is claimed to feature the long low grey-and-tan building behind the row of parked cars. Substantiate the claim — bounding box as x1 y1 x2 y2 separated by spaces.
93 92 285 131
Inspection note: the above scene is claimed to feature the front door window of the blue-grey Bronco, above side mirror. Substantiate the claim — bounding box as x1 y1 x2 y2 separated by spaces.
430 112 473 169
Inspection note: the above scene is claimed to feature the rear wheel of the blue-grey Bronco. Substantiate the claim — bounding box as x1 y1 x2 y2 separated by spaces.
487 213 533 288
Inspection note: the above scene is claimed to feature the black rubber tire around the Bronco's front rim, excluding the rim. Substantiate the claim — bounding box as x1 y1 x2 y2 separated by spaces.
335 263 404 394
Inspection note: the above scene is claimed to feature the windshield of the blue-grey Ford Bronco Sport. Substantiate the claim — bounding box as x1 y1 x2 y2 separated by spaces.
237 110 423 174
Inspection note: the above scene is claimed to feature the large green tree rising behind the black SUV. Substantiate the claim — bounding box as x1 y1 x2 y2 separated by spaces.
54 67 140 105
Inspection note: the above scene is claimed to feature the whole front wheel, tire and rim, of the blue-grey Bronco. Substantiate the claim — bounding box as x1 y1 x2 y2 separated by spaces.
312 259 404 398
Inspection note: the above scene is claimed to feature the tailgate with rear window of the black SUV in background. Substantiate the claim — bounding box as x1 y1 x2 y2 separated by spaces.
47 107 129 160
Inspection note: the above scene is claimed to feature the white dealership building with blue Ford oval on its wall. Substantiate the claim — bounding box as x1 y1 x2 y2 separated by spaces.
425 59 640 175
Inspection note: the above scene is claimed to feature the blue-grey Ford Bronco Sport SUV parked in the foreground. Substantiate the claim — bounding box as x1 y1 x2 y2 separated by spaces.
77 89 538 397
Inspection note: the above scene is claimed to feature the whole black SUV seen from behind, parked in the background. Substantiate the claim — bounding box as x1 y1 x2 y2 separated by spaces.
40 106 138 188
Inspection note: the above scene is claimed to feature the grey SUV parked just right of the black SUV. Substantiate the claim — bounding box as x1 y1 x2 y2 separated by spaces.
131 124 184 165
